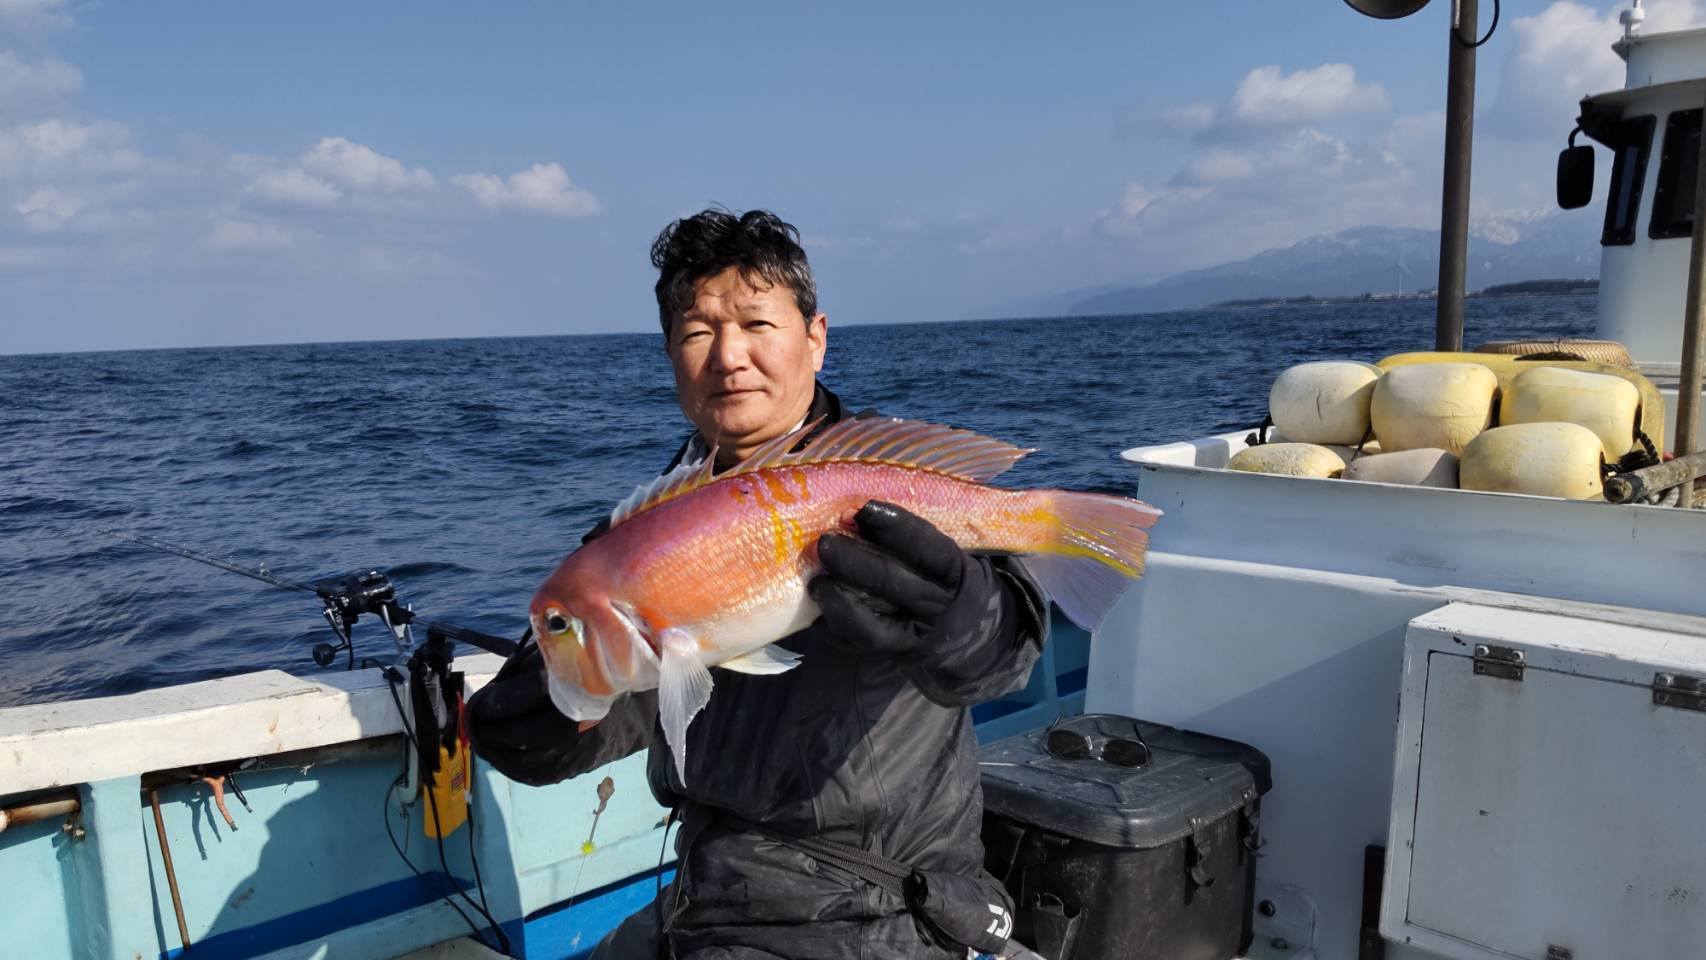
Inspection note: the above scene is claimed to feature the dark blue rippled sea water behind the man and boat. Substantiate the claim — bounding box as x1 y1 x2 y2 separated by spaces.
0 297 1595 706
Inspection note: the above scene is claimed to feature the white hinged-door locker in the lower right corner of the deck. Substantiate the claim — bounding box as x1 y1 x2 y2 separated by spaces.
1382 604 1706 960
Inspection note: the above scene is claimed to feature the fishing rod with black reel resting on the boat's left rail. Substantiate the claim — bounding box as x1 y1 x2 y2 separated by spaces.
121 534 517 670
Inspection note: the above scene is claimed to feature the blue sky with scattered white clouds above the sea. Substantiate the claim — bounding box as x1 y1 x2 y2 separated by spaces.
0 0 1706 353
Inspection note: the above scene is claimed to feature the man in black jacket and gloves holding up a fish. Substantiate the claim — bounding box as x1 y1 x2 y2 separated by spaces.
469 210 1047 960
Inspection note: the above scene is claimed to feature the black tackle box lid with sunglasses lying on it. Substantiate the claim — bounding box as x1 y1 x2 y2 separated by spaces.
979 714 1273 849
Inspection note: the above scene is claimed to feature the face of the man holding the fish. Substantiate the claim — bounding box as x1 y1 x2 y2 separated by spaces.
669 268 829 460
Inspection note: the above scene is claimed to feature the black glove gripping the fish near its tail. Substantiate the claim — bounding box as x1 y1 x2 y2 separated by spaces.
807 500 1015 672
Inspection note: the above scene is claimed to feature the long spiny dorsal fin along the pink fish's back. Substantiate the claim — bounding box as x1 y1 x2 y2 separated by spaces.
611 416 1032 527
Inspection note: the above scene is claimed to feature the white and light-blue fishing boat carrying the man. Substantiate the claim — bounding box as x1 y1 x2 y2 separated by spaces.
0 0 1706 960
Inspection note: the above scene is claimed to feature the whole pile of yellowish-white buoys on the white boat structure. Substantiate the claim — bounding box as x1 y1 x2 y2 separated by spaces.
1227 353 1643 500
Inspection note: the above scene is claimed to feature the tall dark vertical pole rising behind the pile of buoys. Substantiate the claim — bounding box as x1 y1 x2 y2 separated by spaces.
1433 0 1479 351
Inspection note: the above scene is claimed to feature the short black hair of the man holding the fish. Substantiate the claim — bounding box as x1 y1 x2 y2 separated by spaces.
652 206 817 336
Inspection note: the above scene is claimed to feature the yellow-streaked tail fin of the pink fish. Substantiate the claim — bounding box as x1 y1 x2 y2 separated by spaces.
1025 489 1162 629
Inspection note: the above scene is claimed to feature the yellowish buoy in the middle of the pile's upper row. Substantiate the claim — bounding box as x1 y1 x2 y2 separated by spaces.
1368 363 1498 454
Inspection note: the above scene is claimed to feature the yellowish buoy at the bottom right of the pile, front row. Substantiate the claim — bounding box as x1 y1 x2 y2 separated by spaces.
1459 423 1605 500
